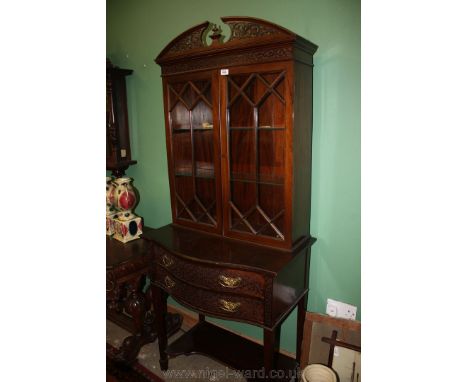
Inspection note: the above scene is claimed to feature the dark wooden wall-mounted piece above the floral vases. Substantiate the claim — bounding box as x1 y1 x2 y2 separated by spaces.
106 60 136 177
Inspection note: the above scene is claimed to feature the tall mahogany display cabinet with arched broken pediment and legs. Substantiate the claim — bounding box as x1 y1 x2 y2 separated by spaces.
144 17 317 379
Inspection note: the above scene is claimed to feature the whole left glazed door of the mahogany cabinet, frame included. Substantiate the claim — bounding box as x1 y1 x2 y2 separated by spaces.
163 71 222 233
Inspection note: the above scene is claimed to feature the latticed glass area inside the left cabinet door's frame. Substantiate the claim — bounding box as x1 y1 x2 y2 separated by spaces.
168 80 216 226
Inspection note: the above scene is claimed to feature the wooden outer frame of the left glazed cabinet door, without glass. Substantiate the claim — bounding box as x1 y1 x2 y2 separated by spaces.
163 70 223 234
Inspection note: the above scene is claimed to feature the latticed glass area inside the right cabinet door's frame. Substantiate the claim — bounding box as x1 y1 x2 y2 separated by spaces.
228 72 286 240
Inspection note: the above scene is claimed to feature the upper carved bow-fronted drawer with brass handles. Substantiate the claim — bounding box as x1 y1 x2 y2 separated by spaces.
156 248 265 299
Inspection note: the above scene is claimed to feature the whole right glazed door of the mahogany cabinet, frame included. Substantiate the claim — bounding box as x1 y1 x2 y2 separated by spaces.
220 63 292 247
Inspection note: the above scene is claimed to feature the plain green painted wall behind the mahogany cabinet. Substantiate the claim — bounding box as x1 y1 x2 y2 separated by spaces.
108 0 361 352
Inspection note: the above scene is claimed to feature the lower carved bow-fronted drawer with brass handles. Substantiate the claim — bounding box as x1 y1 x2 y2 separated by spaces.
154 267 264 324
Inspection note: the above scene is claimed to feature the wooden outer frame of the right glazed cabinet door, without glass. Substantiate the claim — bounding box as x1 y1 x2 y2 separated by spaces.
217 61 294 248
